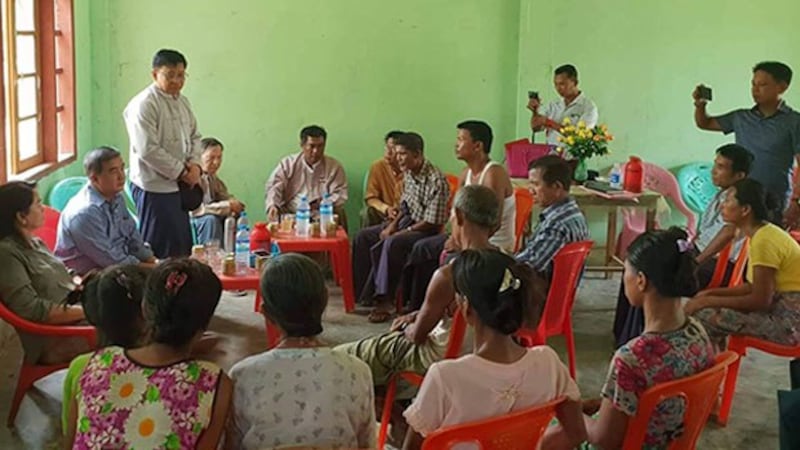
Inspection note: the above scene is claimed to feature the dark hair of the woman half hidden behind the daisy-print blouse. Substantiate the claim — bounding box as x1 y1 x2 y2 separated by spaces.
81 264 150 348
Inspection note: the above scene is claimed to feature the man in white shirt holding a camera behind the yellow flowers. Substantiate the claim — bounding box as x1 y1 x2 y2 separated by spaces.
528 64 598 146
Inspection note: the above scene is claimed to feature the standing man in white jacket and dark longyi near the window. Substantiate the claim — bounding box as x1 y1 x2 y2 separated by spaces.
123 49 201 259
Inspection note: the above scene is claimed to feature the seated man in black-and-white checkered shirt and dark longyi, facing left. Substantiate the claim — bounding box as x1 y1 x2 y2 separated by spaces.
353 132 450 322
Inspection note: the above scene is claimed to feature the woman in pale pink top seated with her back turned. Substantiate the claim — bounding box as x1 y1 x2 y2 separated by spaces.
403 250 586 450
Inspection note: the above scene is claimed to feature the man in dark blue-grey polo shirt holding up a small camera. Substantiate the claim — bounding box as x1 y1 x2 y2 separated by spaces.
692 61 800 227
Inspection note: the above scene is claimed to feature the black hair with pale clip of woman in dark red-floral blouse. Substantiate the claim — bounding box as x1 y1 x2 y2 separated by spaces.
627 227 698 297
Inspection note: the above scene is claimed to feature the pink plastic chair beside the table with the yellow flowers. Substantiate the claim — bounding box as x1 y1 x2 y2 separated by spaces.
616 162 697 259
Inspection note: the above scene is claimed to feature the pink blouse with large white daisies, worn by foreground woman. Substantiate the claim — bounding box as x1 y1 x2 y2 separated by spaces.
73 347 222 450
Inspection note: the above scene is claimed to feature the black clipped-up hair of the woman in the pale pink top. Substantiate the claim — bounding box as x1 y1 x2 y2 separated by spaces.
453 250 546 335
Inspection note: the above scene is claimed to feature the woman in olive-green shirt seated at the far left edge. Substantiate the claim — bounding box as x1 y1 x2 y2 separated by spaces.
0 181 89 364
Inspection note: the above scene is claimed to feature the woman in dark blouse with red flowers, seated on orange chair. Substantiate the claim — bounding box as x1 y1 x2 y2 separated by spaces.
585 227 714 450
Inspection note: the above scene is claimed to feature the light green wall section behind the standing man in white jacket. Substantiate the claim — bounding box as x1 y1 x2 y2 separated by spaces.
81 0 519 223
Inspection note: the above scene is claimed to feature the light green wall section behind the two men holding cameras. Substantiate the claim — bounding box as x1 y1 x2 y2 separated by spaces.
517 0 800 168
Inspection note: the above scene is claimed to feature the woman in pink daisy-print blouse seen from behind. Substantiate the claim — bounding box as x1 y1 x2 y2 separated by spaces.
67 259 232 450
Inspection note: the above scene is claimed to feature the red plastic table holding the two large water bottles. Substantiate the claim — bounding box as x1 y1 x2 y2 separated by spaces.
272 228 356 313
